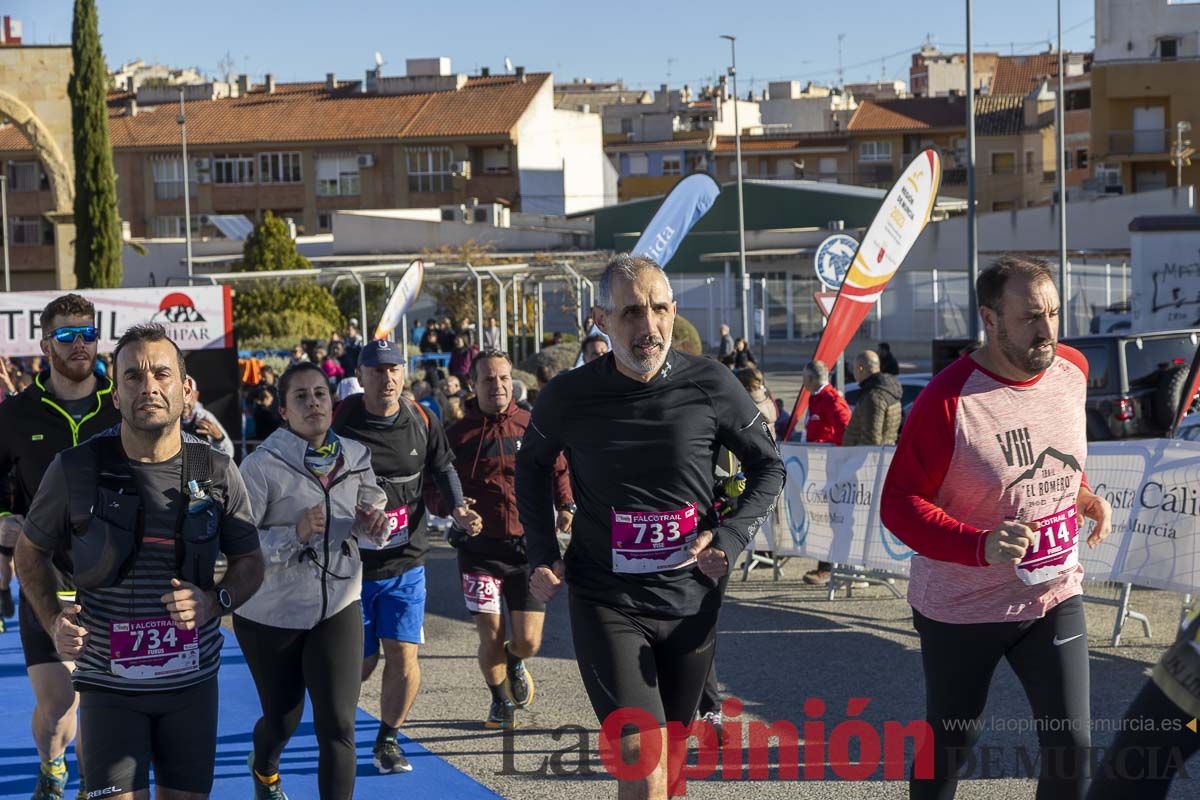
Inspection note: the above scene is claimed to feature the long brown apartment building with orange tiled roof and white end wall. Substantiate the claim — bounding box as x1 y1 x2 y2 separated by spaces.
0 59 604 291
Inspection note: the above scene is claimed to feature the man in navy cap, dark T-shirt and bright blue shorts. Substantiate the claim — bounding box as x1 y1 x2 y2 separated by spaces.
332 339 481 774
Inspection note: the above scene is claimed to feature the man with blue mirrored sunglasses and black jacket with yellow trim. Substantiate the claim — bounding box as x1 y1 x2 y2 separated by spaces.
0 294 121 800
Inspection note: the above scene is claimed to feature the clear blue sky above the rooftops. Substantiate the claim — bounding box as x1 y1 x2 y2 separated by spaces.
11 0 1094 92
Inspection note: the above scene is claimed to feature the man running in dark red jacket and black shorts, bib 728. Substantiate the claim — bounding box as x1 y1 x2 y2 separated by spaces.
446 350 575 729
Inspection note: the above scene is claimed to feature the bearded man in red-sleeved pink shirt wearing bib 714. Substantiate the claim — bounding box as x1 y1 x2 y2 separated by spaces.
881 255 1111 800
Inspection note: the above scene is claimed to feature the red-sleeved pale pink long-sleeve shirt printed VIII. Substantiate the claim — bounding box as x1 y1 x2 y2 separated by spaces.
881 344 1087 624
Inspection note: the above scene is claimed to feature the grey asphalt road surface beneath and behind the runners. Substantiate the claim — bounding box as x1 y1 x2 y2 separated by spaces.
361 545 1200 800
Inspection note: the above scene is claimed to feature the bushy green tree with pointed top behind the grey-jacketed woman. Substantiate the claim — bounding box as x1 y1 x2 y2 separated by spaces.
233 211 344 344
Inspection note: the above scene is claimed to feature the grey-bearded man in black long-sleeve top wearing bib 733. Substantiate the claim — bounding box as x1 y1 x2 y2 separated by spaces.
516 255 784 798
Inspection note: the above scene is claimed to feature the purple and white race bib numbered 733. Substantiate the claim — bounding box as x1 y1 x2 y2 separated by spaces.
612 503 698 573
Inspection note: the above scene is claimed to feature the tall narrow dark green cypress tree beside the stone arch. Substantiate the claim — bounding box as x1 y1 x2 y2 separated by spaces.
67 0 121 289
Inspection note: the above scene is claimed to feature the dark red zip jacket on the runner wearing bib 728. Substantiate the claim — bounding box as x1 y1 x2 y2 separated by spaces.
446 398 572 539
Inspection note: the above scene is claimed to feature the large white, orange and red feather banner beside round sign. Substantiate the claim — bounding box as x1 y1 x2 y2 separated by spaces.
784 150 942 441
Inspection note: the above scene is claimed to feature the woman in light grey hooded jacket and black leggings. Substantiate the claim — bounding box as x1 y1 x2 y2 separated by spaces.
233 362 388 800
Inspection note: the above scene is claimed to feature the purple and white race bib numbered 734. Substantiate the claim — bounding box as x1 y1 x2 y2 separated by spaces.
108 616 200 680
